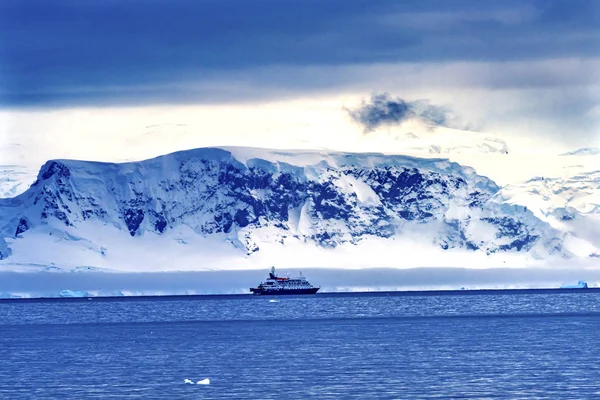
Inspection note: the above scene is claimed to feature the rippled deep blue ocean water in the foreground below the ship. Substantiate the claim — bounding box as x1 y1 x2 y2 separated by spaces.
0 291 600 399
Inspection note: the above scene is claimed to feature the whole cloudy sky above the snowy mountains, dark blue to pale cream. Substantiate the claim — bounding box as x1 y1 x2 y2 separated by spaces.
0 0 600 173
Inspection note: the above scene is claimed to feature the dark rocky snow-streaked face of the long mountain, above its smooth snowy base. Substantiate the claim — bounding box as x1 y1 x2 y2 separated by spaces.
0 148 569 266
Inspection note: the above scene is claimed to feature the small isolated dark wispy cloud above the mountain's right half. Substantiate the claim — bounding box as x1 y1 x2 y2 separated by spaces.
347 93 467 132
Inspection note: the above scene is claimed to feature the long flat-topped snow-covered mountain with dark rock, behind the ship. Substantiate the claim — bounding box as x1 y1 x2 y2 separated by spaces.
0 147 584 271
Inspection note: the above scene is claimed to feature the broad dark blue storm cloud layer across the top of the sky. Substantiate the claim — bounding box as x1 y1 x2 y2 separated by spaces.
0 0 600 107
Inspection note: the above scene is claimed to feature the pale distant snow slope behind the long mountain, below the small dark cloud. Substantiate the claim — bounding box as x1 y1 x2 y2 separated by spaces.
342 119 600 186
